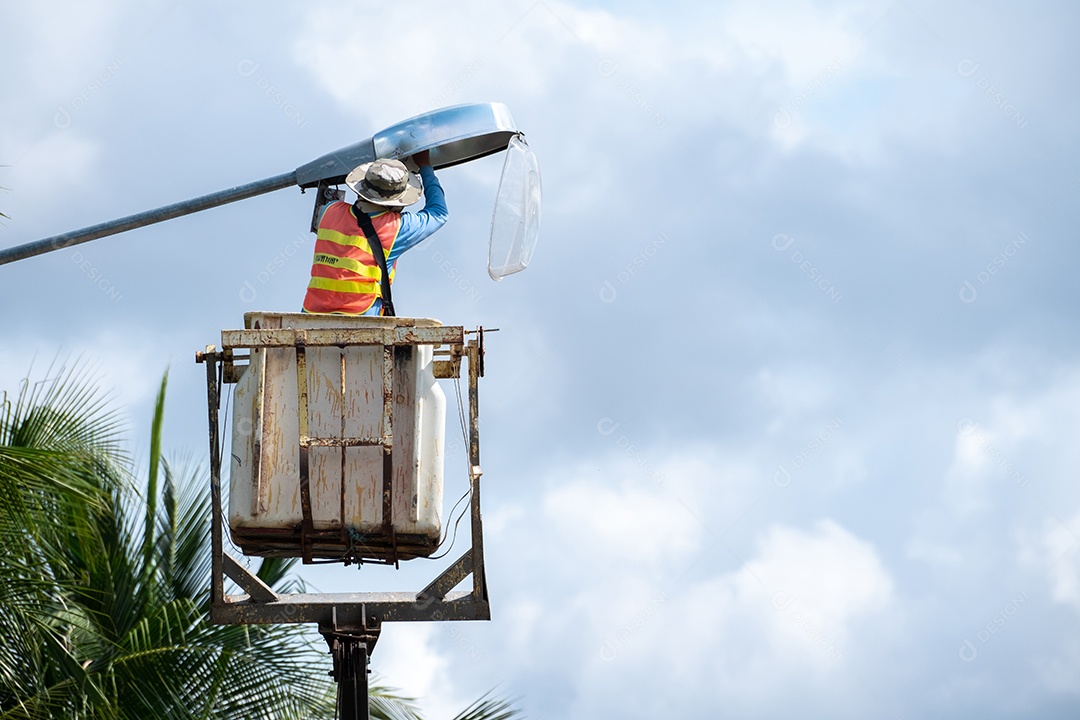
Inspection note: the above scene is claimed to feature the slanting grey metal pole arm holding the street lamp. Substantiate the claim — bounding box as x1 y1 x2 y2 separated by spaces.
0 171 296 264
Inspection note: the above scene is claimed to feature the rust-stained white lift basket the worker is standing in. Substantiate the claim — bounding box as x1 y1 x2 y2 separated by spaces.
222 313 449 562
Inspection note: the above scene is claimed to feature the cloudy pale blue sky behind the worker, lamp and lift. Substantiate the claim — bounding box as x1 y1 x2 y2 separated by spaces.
0 0 1080 720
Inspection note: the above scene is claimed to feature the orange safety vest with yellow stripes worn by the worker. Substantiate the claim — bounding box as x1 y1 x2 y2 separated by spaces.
303 202 402 315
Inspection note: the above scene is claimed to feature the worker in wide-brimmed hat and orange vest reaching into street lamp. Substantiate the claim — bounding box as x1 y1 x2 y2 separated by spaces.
303 150 447 315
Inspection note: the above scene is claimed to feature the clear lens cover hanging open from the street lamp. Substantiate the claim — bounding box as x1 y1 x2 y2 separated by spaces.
487 135 541 281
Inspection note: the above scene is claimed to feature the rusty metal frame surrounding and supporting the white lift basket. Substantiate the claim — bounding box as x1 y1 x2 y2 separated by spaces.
195 326 491 630
